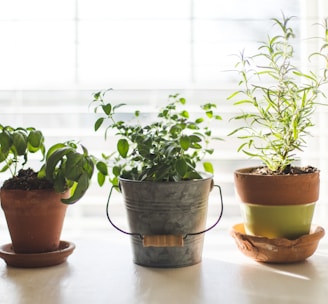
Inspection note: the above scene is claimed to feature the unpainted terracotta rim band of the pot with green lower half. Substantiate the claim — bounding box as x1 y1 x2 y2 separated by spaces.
234 168 320 206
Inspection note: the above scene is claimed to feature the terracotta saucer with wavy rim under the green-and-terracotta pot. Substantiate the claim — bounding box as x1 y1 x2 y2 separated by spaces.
231 224 325 263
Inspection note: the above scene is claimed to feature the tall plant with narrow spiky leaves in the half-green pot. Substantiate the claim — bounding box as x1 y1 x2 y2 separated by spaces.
228 15 328 174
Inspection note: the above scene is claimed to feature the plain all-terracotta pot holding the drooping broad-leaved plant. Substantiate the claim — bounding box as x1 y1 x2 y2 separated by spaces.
0 190 69 253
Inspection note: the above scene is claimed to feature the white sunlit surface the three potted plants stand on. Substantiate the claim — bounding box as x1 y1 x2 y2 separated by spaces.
0 216 328 304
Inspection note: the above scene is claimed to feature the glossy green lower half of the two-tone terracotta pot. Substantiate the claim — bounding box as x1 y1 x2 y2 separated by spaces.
240 203 315 239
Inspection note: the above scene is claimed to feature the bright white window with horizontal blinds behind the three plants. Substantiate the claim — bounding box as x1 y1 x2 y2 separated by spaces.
0 0 328 233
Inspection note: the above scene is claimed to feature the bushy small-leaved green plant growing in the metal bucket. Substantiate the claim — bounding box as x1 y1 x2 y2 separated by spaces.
93 90 221 185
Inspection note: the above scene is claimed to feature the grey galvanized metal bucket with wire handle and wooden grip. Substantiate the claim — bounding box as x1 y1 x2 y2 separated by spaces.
106 175 223 268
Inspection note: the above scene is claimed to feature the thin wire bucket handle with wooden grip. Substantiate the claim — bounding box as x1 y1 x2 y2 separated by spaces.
106 185 223 247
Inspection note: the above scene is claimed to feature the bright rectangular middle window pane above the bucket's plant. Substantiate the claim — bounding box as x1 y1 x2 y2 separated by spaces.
79 19 190 84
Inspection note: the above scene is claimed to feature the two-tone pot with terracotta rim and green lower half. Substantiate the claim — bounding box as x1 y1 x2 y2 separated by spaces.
234 168 320 239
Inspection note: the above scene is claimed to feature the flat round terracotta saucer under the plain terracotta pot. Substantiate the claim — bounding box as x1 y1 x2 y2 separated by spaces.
0 241 75 268
